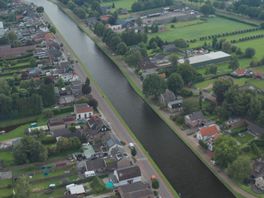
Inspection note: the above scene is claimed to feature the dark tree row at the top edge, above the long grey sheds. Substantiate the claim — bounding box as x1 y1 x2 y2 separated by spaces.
131 0 173 12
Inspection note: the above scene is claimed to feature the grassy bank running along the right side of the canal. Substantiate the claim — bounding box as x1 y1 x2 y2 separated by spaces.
50 1 251 197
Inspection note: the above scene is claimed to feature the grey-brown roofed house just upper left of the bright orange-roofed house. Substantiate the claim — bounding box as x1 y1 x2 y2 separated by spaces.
184 111 207 128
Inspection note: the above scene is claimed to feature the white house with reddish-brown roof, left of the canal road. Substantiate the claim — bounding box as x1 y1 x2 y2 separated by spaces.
74 103 93 120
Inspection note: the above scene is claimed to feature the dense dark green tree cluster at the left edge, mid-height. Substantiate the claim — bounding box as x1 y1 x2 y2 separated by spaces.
0 79 56 119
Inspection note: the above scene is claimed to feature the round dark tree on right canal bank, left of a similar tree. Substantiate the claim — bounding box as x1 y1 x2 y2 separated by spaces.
143 74 166 97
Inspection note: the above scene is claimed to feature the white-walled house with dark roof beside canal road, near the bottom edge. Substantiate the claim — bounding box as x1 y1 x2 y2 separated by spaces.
112 166 142 187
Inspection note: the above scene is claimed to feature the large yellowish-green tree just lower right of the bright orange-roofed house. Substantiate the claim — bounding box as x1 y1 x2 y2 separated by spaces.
214 135 239 168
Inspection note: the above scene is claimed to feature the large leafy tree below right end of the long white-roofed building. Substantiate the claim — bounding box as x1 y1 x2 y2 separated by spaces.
213 78 233 104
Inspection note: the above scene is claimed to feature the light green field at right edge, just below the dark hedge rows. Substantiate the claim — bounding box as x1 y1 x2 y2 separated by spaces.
236 38 264 59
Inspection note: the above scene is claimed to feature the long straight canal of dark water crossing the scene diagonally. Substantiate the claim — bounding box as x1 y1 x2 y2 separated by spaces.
26 0 234 198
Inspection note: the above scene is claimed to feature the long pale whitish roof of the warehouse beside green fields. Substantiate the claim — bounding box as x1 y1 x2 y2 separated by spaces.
179 51 230 65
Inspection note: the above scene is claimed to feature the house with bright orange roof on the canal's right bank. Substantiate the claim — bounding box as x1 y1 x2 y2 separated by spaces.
196 124 220 151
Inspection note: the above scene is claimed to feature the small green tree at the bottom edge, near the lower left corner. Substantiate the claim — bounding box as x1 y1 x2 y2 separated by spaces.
14 176 31 198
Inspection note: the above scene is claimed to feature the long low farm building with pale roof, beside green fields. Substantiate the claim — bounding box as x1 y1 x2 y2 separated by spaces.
179 51 230 66
